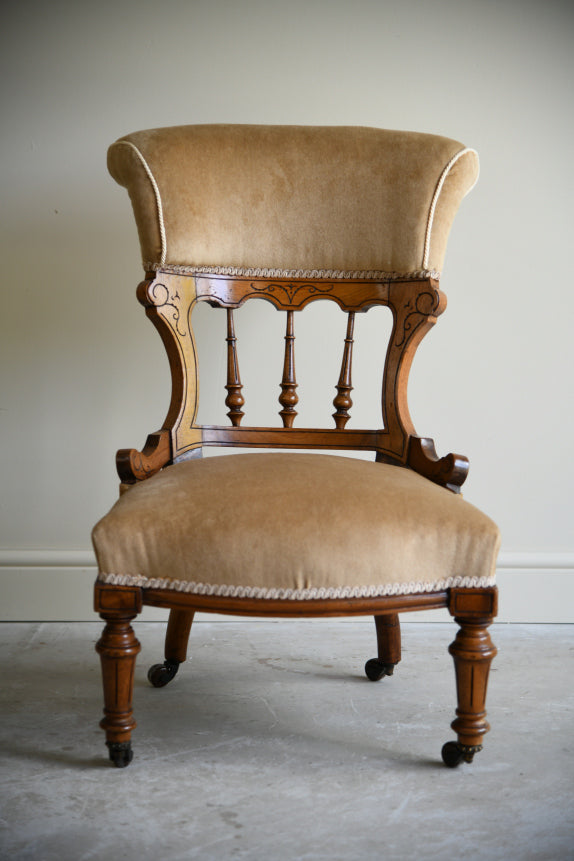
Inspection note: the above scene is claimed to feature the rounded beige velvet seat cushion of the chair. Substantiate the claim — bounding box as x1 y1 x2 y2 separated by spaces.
93 453 499 600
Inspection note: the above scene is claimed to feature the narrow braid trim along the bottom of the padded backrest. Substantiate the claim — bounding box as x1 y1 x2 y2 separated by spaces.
143 263 440 281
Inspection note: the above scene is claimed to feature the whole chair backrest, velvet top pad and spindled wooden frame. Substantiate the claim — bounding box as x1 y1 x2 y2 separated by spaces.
108 125 478 489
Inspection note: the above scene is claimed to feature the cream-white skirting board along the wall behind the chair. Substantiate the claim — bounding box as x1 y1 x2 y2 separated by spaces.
0 550 574 624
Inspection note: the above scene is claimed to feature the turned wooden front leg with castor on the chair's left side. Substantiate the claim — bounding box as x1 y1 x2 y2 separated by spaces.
96 586 141 768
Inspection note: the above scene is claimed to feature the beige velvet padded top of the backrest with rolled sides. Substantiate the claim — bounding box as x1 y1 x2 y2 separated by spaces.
108 125 478 277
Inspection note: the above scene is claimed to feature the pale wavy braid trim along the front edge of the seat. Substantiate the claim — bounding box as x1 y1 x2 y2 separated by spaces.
98 574 495 601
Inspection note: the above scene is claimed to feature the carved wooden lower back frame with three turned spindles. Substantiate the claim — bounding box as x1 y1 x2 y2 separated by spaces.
117 270 468 491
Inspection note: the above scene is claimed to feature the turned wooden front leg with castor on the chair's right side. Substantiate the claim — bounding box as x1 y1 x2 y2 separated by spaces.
442 616 497 768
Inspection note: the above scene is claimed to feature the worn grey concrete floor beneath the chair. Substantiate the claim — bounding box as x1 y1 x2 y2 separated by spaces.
0 620 574 861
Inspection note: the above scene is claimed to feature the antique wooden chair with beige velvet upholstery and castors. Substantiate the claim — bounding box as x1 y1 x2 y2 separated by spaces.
93 125 499 767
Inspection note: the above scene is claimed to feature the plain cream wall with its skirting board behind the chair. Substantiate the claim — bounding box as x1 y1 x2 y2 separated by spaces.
0 0 574 621
